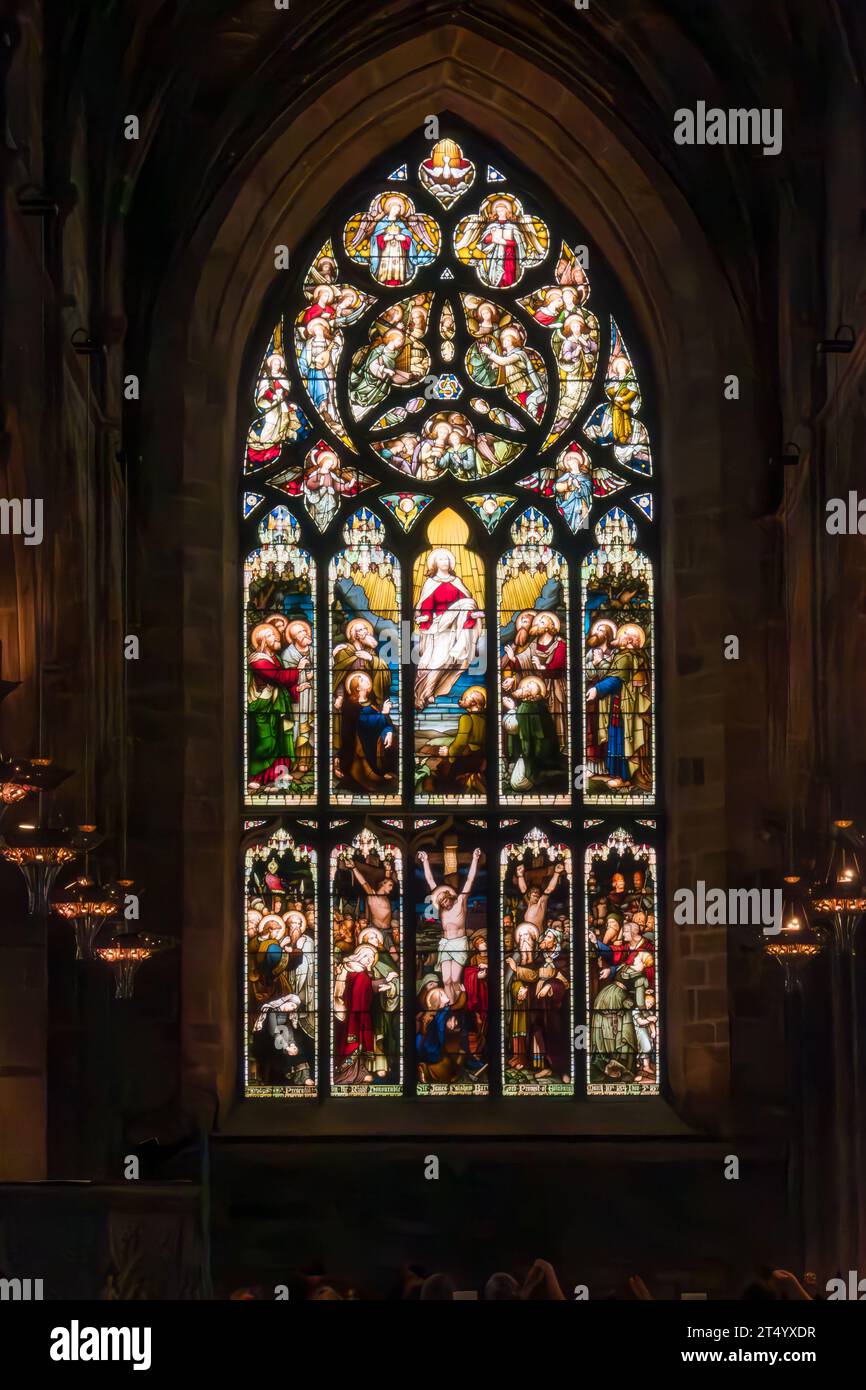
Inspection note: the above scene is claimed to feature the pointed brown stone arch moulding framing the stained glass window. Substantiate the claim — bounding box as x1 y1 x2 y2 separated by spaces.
145 26 753 1123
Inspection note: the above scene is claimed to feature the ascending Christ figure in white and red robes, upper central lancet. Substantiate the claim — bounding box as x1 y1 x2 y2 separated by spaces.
414 549 484 709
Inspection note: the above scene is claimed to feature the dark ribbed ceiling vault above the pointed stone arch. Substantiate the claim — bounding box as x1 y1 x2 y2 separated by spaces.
30 0 865 347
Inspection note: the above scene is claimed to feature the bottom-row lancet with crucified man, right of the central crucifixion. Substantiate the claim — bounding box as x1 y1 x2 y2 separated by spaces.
500 830 574 1095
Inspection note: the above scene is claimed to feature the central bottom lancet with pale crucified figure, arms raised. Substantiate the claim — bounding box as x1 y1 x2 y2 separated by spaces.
414 834 489 1095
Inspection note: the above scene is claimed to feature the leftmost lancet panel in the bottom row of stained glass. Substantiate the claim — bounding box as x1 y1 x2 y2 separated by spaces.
243 830 318 1099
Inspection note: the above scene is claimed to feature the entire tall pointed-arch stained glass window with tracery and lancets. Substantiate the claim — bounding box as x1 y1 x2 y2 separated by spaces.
238 132 664 1111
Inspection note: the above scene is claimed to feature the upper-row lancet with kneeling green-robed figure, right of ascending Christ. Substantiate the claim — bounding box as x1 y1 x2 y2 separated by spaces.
496 507 571 806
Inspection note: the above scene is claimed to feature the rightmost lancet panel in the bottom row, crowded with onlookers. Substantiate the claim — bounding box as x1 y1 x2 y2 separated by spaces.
584 830 660 1095
